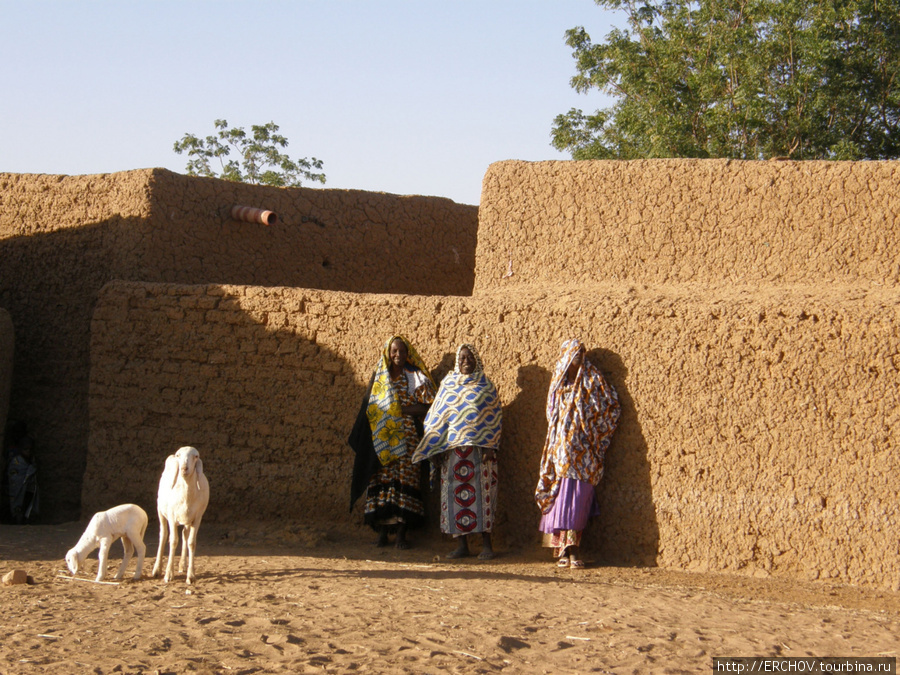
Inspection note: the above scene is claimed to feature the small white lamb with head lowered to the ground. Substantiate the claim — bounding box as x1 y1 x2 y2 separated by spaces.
66 504 148 581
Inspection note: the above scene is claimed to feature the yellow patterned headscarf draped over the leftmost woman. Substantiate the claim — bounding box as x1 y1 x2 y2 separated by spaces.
366 335 437 466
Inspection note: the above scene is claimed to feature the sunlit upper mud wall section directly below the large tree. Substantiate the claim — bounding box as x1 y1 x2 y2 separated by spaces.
475 160 900 290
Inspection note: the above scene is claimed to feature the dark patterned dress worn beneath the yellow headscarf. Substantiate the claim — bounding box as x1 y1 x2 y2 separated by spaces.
364 364 434 527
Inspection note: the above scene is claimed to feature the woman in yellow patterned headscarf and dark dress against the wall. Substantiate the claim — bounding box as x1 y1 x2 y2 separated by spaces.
348 335 436 549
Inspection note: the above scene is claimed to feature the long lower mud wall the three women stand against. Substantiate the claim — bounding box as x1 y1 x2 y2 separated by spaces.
89 283 900 589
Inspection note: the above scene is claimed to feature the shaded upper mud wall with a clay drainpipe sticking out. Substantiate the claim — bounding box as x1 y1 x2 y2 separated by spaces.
142 170 478 295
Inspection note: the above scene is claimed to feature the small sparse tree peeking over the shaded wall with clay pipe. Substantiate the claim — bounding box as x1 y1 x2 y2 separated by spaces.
175 120 325 187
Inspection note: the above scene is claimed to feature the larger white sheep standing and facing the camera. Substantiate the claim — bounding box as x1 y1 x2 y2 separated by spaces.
152 446 209 584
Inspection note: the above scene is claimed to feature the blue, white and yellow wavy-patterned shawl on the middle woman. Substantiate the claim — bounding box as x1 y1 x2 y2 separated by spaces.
412 344 502 463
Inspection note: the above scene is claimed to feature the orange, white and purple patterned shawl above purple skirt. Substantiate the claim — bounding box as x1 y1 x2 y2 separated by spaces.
534 338 622 513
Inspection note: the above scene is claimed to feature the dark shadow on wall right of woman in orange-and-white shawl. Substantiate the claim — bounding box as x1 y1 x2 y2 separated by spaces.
585 349 659 566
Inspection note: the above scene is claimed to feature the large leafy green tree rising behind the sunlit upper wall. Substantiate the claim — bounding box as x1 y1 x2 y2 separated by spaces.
552 0 900 159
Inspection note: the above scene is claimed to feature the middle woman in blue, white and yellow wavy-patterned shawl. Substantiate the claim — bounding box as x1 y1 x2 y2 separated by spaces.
412 344 501 560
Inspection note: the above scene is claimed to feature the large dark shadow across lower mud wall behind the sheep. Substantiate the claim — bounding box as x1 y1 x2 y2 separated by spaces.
82 285 362 528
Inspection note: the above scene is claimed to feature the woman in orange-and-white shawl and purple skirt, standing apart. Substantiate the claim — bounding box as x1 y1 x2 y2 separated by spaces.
534 338 621 567
